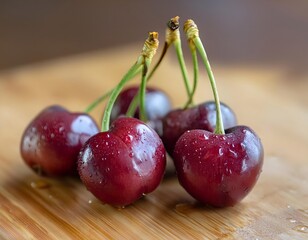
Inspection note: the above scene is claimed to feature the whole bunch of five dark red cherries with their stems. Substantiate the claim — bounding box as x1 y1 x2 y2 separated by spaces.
20 17 263 207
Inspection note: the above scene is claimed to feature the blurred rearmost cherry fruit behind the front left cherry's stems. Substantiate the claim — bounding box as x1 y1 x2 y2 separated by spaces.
111 86 171 134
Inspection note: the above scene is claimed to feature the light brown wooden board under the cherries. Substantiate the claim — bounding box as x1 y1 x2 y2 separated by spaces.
0 44 308 240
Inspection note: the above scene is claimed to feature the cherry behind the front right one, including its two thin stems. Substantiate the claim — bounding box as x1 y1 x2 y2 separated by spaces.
161 17 237 157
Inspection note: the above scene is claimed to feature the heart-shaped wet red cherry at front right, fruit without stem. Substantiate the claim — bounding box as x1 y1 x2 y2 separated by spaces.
174 126 263 207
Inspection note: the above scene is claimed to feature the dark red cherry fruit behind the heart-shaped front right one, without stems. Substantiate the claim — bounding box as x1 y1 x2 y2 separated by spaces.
161 101 237 156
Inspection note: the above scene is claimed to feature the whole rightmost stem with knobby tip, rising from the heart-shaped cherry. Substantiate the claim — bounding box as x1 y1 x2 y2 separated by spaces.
184 19 225 134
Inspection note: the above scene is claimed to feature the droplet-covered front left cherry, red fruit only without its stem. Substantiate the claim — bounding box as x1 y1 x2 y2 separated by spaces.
78 117 166 206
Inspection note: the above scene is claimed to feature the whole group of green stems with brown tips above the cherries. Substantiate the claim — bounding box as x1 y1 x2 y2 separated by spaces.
86 16 224 134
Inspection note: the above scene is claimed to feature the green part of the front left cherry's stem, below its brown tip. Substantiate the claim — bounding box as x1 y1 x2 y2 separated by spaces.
101 61 142 132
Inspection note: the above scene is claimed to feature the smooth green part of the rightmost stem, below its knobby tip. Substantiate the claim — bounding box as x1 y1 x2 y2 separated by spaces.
193 37 225 134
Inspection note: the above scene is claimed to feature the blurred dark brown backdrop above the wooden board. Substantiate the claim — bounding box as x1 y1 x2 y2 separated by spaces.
0 0 308 73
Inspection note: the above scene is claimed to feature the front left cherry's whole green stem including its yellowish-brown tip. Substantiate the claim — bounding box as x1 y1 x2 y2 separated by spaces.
101 32 159 132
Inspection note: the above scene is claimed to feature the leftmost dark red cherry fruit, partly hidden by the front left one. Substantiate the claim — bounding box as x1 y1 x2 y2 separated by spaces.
20 105 99 176
